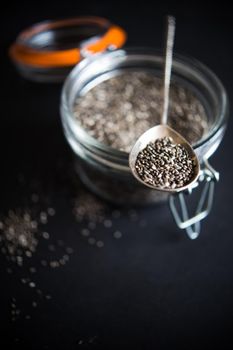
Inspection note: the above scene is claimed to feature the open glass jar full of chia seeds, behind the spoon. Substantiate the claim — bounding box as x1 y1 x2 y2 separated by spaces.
61 49 228 205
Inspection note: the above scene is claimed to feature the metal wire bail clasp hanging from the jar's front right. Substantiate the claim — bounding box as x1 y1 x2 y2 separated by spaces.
169 160 219 239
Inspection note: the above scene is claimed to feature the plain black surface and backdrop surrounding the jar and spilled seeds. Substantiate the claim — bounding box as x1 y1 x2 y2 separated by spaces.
0 1 233 349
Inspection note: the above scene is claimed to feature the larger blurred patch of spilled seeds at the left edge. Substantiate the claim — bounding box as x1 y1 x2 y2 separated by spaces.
0 193 74 322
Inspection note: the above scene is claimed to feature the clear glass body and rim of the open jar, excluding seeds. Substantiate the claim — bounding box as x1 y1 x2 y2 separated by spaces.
61 49 228 238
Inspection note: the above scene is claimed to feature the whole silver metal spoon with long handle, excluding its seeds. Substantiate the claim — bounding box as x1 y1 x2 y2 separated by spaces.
129 16 200 193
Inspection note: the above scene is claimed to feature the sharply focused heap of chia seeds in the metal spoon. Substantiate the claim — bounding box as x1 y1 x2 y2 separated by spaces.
135 137 195 189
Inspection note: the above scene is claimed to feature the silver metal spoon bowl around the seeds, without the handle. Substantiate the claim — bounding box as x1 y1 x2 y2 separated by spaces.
129 124 200 193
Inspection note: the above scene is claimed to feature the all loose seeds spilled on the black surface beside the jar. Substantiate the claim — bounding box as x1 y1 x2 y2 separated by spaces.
0 162 147 322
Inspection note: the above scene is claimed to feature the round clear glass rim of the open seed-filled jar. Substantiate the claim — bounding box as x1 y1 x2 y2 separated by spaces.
61 47 229 159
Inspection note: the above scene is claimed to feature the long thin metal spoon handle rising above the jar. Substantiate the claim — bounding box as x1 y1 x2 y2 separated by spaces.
161 16 176 124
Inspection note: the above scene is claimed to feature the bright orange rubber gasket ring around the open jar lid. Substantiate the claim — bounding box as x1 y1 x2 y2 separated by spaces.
9 17 127 68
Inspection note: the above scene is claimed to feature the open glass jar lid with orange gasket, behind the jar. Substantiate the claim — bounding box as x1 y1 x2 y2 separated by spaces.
9 17 126 82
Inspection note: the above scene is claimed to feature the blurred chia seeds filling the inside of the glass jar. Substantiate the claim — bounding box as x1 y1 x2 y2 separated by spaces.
74 71 208 152
